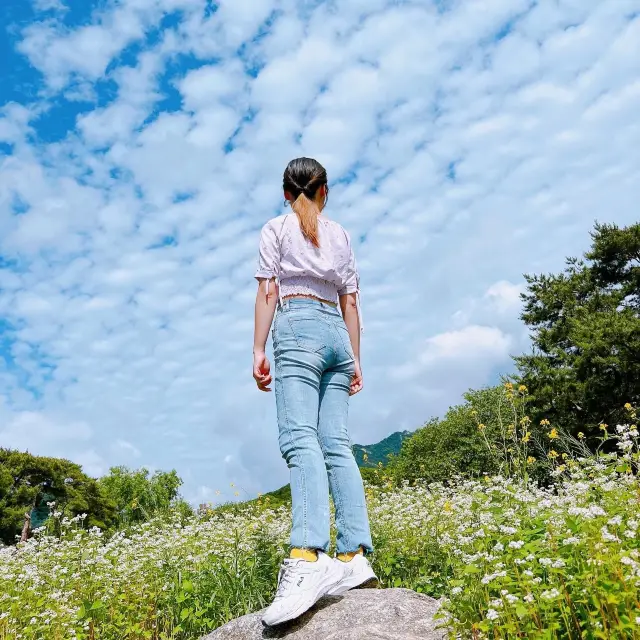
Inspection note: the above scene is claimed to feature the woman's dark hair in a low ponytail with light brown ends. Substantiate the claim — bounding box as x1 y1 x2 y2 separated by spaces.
282 158 329 247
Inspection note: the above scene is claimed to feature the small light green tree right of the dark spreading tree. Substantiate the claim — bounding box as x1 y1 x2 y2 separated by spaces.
98 467 192 528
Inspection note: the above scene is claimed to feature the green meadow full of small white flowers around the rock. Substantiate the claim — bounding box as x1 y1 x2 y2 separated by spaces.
0 428 640 640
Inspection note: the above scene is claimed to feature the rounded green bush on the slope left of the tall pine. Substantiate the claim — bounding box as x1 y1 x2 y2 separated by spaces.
389 387 506 482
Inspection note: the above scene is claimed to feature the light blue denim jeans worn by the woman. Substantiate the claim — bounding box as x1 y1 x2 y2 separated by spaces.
273 298 372 553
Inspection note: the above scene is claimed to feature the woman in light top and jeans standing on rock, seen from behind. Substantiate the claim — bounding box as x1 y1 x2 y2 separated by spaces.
253 158 376 625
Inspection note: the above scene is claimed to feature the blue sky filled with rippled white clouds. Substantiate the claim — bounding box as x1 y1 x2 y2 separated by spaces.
0 0 640 503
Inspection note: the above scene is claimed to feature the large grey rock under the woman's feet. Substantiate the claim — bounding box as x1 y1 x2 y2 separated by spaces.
202 589 447 640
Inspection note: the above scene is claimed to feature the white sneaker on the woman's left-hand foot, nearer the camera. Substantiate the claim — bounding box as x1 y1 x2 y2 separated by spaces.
262 551 343 627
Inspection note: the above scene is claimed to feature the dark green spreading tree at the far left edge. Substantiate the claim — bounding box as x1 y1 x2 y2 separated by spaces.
0 449 114 544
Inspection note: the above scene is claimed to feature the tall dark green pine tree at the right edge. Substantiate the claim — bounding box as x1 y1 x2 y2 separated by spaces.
515 224 640 443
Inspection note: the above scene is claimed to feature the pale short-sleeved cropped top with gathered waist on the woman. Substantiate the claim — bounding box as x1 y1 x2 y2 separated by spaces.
255 213 362 328
